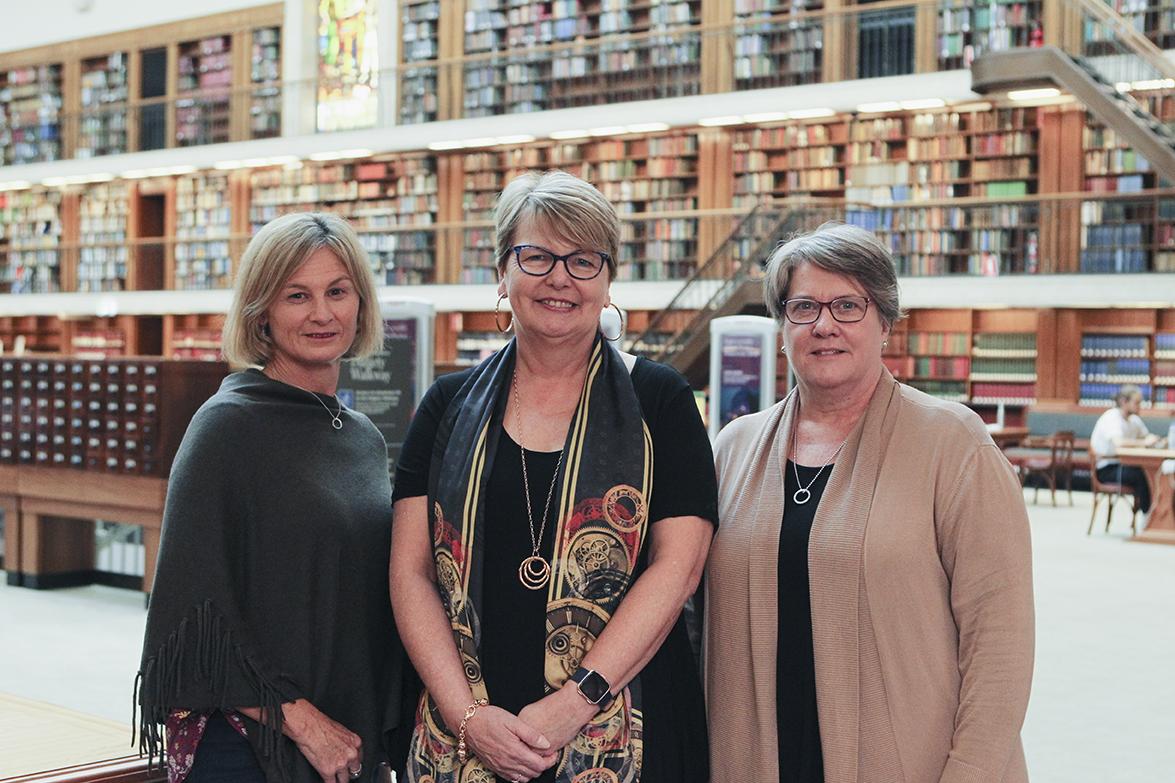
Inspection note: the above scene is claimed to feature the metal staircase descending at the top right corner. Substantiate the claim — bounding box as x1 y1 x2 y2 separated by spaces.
971 0 1175 182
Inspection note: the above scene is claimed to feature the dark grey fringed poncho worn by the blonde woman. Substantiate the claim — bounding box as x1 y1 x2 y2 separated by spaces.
136 370 403 783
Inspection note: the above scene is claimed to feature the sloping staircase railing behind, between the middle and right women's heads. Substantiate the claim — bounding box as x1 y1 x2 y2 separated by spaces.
629 203 844 369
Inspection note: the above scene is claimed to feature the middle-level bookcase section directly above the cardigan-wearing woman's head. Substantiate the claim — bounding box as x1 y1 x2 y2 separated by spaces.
845 103 1040 276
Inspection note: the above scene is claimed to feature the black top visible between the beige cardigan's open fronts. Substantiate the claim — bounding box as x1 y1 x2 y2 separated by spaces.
776 460 832 783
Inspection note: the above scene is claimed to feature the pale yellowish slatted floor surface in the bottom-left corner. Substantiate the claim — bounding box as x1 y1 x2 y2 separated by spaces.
0 694 135 779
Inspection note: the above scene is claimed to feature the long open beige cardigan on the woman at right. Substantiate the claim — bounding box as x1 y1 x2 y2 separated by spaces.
704 373 1034 783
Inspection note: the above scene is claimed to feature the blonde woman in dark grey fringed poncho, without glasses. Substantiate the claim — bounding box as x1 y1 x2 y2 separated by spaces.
137 213 403 783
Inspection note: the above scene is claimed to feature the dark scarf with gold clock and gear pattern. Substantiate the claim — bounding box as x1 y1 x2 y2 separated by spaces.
409 335 653 783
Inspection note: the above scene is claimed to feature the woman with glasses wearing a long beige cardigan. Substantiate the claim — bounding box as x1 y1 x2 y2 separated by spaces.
705 223 1033 783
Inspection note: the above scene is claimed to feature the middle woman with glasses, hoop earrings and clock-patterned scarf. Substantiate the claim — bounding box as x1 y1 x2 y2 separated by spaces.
391 172 717 783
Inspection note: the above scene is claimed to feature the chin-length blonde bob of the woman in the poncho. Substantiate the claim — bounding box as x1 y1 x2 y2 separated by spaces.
221 212 383 367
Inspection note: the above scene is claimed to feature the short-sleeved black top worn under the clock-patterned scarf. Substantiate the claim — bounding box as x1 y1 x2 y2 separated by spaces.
392 359 718 783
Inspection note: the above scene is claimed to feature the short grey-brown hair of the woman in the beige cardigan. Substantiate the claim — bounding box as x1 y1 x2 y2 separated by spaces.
763 221 902 329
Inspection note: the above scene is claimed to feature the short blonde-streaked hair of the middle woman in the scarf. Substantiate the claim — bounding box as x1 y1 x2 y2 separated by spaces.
494 170 620 280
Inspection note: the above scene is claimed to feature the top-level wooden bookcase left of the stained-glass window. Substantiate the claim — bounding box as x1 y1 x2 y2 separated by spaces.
0 2 279 165
